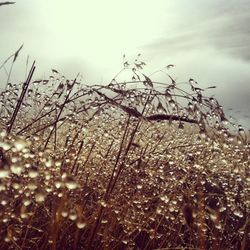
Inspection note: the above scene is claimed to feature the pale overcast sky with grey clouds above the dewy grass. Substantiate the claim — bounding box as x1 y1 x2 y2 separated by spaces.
0 0 250 127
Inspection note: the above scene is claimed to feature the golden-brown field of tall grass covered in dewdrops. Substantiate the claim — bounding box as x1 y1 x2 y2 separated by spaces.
0 54 250 250
